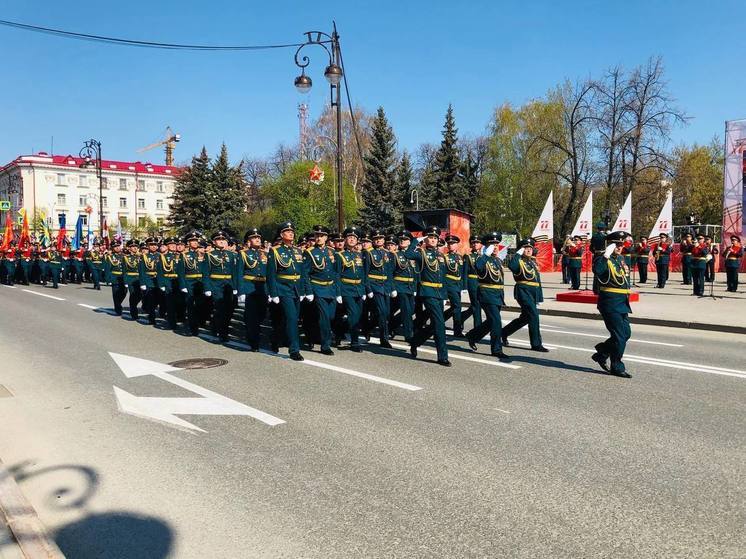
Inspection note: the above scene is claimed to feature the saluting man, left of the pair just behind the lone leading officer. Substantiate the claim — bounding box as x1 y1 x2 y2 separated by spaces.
466 231 510 361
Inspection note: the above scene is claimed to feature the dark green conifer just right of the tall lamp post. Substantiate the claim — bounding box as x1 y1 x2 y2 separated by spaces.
358 107 400 231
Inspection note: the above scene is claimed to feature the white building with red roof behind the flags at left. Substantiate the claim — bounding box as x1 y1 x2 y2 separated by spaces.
0 152 179 234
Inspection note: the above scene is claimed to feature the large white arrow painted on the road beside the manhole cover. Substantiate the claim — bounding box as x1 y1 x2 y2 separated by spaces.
109 352 285 433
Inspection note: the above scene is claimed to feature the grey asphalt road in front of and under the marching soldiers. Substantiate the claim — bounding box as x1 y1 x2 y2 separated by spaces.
0 286 746 559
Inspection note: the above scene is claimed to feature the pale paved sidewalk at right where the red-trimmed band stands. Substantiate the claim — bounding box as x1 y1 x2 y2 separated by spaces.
488 272 746 334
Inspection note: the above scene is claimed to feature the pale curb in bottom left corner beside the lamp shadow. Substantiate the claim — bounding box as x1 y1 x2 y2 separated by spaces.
0 460 65 559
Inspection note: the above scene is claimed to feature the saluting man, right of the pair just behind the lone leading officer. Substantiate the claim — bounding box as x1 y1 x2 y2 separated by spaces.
502 238 548 352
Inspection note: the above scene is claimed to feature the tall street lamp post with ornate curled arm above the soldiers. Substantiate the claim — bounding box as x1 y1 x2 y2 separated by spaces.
295 23 344 231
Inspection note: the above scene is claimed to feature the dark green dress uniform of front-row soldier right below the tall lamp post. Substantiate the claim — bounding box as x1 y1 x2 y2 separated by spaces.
336 244 368 351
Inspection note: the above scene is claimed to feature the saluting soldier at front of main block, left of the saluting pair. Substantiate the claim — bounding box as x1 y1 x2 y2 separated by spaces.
404 225 451 367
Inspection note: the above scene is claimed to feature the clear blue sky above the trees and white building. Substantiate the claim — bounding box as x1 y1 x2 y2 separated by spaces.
0 0 746 163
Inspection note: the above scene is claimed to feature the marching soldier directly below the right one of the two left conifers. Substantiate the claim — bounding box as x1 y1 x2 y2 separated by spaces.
204 231 238 342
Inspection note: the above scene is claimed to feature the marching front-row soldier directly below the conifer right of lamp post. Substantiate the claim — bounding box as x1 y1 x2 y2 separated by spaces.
363 229 397 349
